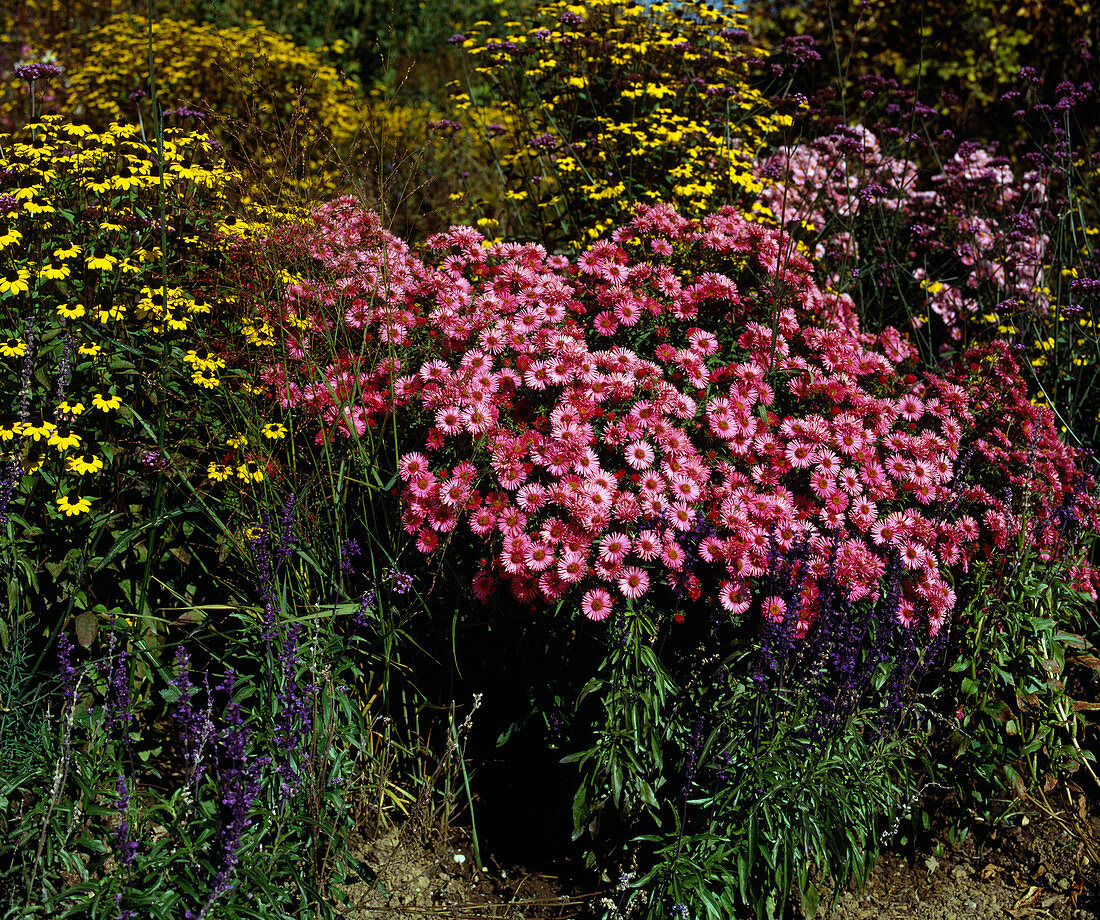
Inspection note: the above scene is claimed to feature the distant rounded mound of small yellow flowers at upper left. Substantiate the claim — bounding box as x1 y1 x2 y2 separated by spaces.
21 13 364 200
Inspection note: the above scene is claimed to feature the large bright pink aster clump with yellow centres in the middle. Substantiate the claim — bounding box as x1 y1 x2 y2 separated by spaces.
255 198 1093 636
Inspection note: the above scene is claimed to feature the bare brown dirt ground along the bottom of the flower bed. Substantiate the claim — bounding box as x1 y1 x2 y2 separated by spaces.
334 788 1100 920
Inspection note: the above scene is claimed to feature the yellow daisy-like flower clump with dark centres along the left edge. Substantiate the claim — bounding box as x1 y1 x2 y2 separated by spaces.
0 116 297 521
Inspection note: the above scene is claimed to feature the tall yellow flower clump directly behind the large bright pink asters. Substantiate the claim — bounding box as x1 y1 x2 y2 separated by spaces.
446 0 791 247
